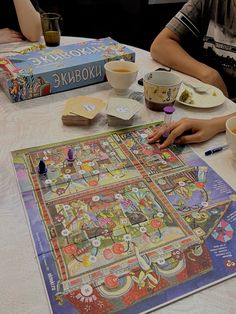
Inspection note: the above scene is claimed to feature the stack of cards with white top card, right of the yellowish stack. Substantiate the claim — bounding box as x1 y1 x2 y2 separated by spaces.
106 97 142 126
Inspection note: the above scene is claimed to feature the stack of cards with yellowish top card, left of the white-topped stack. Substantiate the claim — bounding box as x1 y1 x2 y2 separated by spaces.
62 96 106 125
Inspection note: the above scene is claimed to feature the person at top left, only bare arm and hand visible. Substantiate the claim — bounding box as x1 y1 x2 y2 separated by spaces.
0 0 41 44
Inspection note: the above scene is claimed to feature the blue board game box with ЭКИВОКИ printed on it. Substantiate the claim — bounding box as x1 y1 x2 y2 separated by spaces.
0 37 135 102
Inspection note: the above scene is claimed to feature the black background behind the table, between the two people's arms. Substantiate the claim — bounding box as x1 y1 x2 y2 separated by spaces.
38 0 186 50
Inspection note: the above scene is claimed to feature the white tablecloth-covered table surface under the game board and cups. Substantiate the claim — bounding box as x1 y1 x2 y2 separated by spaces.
0 37 236 314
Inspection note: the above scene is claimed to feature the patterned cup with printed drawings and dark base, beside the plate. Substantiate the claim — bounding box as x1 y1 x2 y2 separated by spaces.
143 71 182 111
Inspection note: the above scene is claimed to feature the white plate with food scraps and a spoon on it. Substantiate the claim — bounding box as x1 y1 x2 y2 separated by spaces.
176 83 225 108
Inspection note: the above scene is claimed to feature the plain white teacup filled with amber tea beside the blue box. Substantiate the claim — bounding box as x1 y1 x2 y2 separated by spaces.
104 60 138 95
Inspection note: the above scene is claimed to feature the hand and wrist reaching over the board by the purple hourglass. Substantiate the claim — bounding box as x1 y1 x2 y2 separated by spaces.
148 112 236 149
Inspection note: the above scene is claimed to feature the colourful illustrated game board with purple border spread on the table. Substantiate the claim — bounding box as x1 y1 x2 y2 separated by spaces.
12 124 236 314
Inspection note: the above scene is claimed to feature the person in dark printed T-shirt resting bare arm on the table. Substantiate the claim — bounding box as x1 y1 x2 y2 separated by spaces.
150 0 236 98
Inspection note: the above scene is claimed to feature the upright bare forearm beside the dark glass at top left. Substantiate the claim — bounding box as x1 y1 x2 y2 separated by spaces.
13 0 41 41
